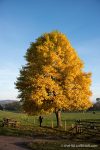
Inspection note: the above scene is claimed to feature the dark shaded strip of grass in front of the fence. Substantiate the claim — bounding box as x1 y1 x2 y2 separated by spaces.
0 126 100 150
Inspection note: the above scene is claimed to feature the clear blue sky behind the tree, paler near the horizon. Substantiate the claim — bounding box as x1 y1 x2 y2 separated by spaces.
0 0 100 101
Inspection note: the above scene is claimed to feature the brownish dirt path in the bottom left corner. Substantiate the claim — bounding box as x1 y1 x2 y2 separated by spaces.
0 136 33 150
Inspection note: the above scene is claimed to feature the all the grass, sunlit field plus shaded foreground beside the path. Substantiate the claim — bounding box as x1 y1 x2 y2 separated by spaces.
0 111 100 150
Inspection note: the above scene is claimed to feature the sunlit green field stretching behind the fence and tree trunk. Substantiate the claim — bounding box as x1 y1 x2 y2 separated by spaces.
0 111 100 127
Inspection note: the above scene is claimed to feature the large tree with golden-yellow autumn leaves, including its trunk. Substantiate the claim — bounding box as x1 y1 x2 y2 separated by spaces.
16 31 91 127
